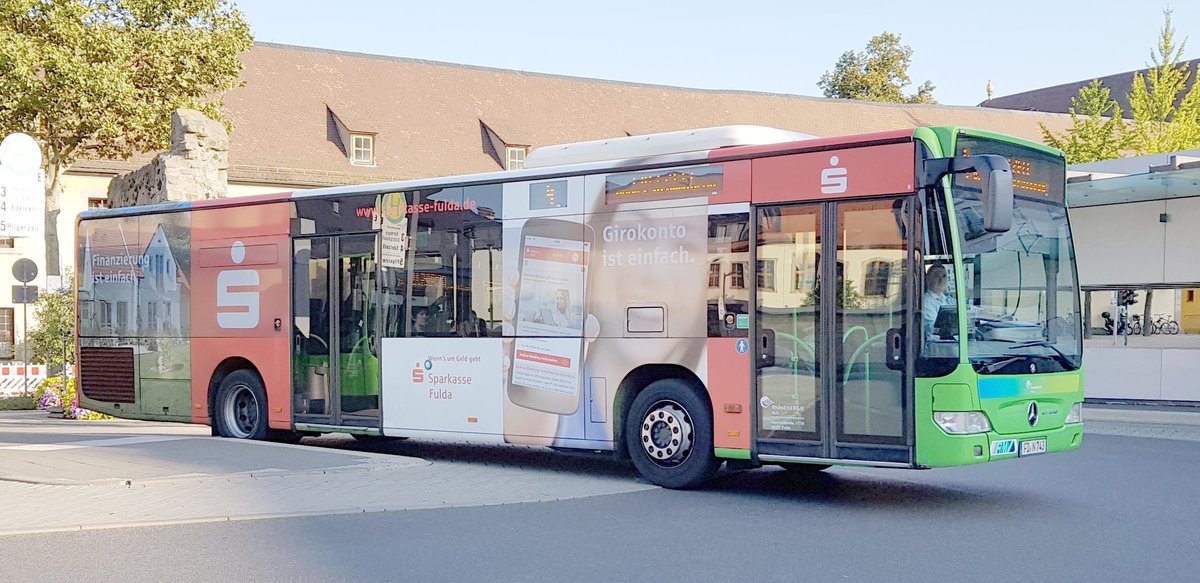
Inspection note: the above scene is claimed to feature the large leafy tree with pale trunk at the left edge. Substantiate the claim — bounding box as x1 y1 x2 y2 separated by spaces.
0 0 253 275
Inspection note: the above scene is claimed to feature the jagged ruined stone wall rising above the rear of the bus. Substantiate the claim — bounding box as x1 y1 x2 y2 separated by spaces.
108 109 229 209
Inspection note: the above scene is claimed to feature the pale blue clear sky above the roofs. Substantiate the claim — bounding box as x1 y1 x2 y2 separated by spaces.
233 0 1200 106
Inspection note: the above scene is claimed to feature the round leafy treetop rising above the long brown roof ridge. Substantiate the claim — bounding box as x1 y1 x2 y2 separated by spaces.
817 32 937 103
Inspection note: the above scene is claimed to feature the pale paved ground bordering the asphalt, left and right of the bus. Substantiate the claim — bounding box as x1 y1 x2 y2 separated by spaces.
0 408 1200 535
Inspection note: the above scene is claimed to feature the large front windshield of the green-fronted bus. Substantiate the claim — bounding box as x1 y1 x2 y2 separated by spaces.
953 136 1082 374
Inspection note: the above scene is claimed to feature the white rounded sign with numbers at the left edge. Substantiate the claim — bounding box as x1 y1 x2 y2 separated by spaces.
0 133 46 236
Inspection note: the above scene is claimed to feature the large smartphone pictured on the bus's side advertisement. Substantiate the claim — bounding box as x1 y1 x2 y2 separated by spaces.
509 218 594 415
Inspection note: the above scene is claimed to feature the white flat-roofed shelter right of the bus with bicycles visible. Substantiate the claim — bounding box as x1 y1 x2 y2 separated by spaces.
1067 150 1200 404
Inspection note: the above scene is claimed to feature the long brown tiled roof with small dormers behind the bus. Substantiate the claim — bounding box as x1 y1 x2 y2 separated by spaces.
76 43 1084 186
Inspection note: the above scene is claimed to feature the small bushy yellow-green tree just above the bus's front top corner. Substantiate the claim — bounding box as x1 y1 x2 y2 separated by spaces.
1039 79 1126 164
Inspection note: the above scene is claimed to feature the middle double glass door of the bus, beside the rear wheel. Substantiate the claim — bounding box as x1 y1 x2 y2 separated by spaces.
292 235 379 428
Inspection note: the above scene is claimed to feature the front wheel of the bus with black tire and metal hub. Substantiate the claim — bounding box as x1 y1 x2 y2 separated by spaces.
625 379 721 489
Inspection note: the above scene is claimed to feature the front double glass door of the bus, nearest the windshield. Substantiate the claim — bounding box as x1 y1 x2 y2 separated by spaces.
754 197 914 465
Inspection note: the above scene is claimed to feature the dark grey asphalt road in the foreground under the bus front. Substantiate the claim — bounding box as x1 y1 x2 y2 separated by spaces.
0 434 1200 582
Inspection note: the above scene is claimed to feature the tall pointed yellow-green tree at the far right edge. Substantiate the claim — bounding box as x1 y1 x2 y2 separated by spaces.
1128 10 1200 155
